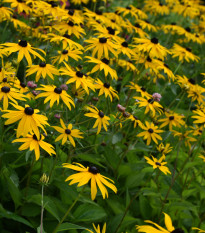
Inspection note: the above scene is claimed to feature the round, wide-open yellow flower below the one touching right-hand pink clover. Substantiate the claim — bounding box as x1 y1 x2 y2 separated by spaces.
137 121 163 145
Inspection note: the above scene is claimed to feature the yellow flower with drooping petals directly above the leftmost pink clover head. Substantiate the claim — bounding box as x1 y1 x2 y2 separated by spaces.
26 62 59 82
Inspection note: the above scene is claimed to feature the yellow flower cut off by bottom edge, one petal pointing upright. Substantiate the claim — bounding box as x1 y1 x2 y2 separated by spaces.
136 213 184 233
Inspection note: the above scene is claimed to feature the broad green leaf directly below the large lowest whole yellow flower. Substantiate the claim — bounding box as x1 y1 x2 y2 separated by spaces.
73 203 106 222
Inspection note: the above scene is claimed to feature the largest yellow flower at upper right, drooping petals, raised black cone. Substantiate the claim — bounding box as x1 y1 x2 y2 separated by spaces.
133 37 170 60
